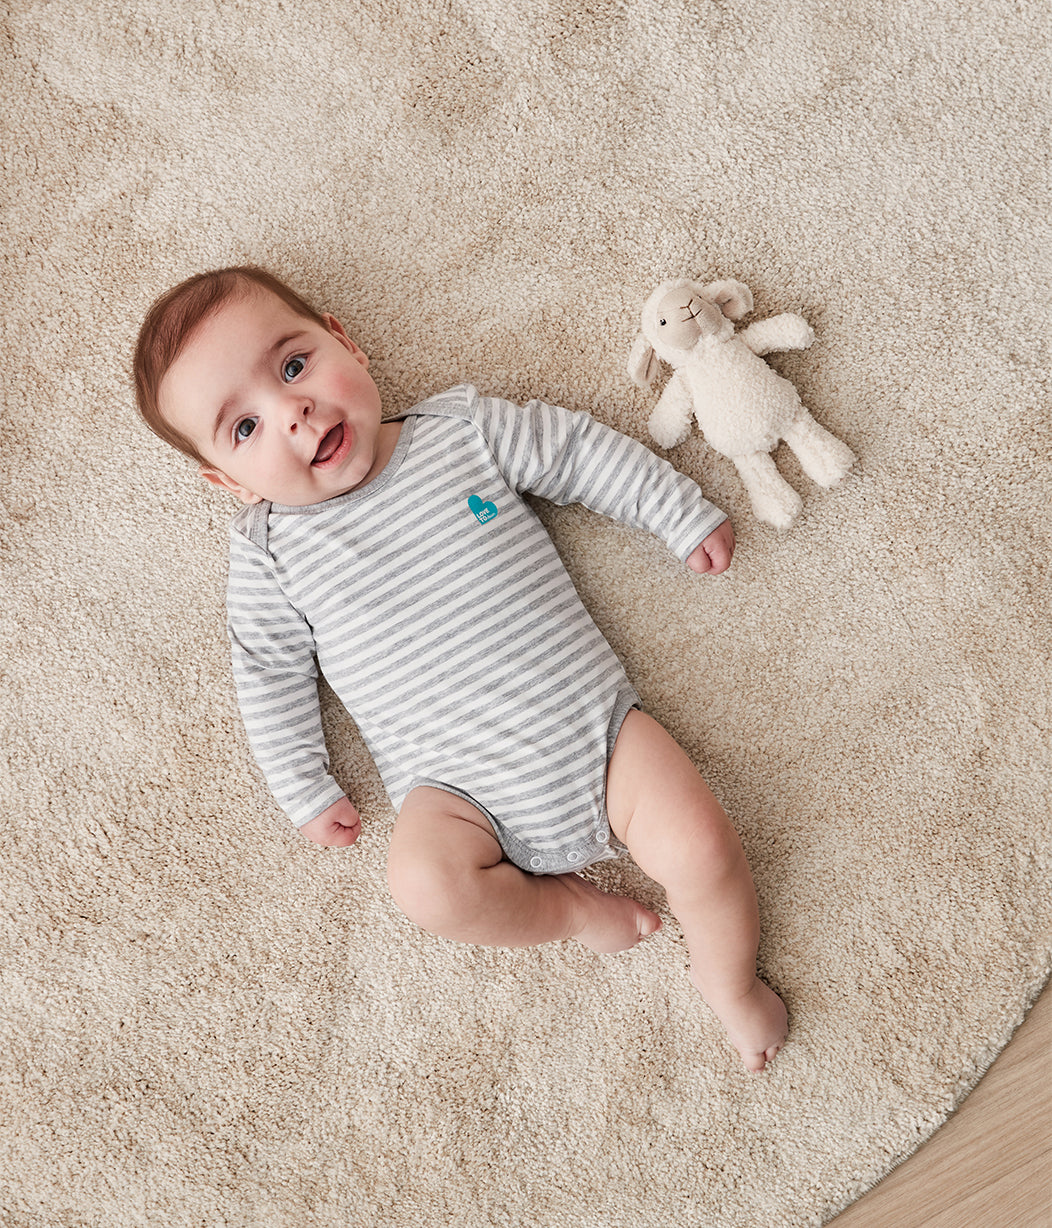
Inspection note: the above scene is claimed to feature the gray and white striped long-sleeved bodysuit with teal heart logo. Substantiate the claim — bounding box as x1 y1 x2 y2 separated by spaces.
227 387 725 873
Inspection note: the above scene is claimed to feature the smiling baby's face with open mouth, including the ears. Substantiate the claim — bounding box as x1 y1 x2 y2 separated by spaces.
160 287 383 507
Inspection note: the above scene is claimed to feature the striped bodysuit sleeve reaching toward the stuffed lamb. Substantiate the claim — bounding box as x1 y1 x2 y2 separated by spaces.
469 391 727 560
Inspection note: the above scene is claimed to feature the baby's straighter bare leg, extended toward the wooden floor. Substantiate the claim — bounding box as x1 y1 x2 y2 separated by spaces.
606 711 787 1071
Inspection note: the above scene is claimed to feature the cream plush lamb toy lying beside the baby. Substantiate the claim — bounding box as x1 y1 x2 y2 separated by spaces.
628 279 854 529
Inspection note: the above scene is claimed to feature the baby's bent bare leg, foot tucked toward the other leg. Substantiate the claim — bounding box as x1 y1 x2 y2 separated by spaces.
388 787 660 952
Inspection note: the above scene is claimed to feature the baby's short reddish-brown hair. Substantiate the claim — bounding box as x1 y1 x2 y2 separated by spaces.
133 264 325 464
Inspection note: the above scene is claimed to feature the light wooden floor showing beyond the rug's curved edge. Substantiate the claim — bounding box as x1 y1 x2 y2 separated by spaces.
831 986 1052 1228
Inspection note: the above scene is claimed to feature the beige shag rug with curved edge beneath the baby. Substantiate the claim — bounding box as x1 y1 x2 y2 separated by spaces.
0 0 1052 1228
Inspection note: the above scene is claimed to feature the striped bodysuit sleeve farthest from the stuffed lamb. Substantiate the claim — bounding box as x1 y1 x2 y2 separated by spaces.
227 521 344 828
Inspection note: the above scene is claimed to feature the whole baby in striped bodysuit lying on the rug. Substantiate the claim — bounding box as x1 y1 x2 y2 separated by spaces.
135 268 787 1071
